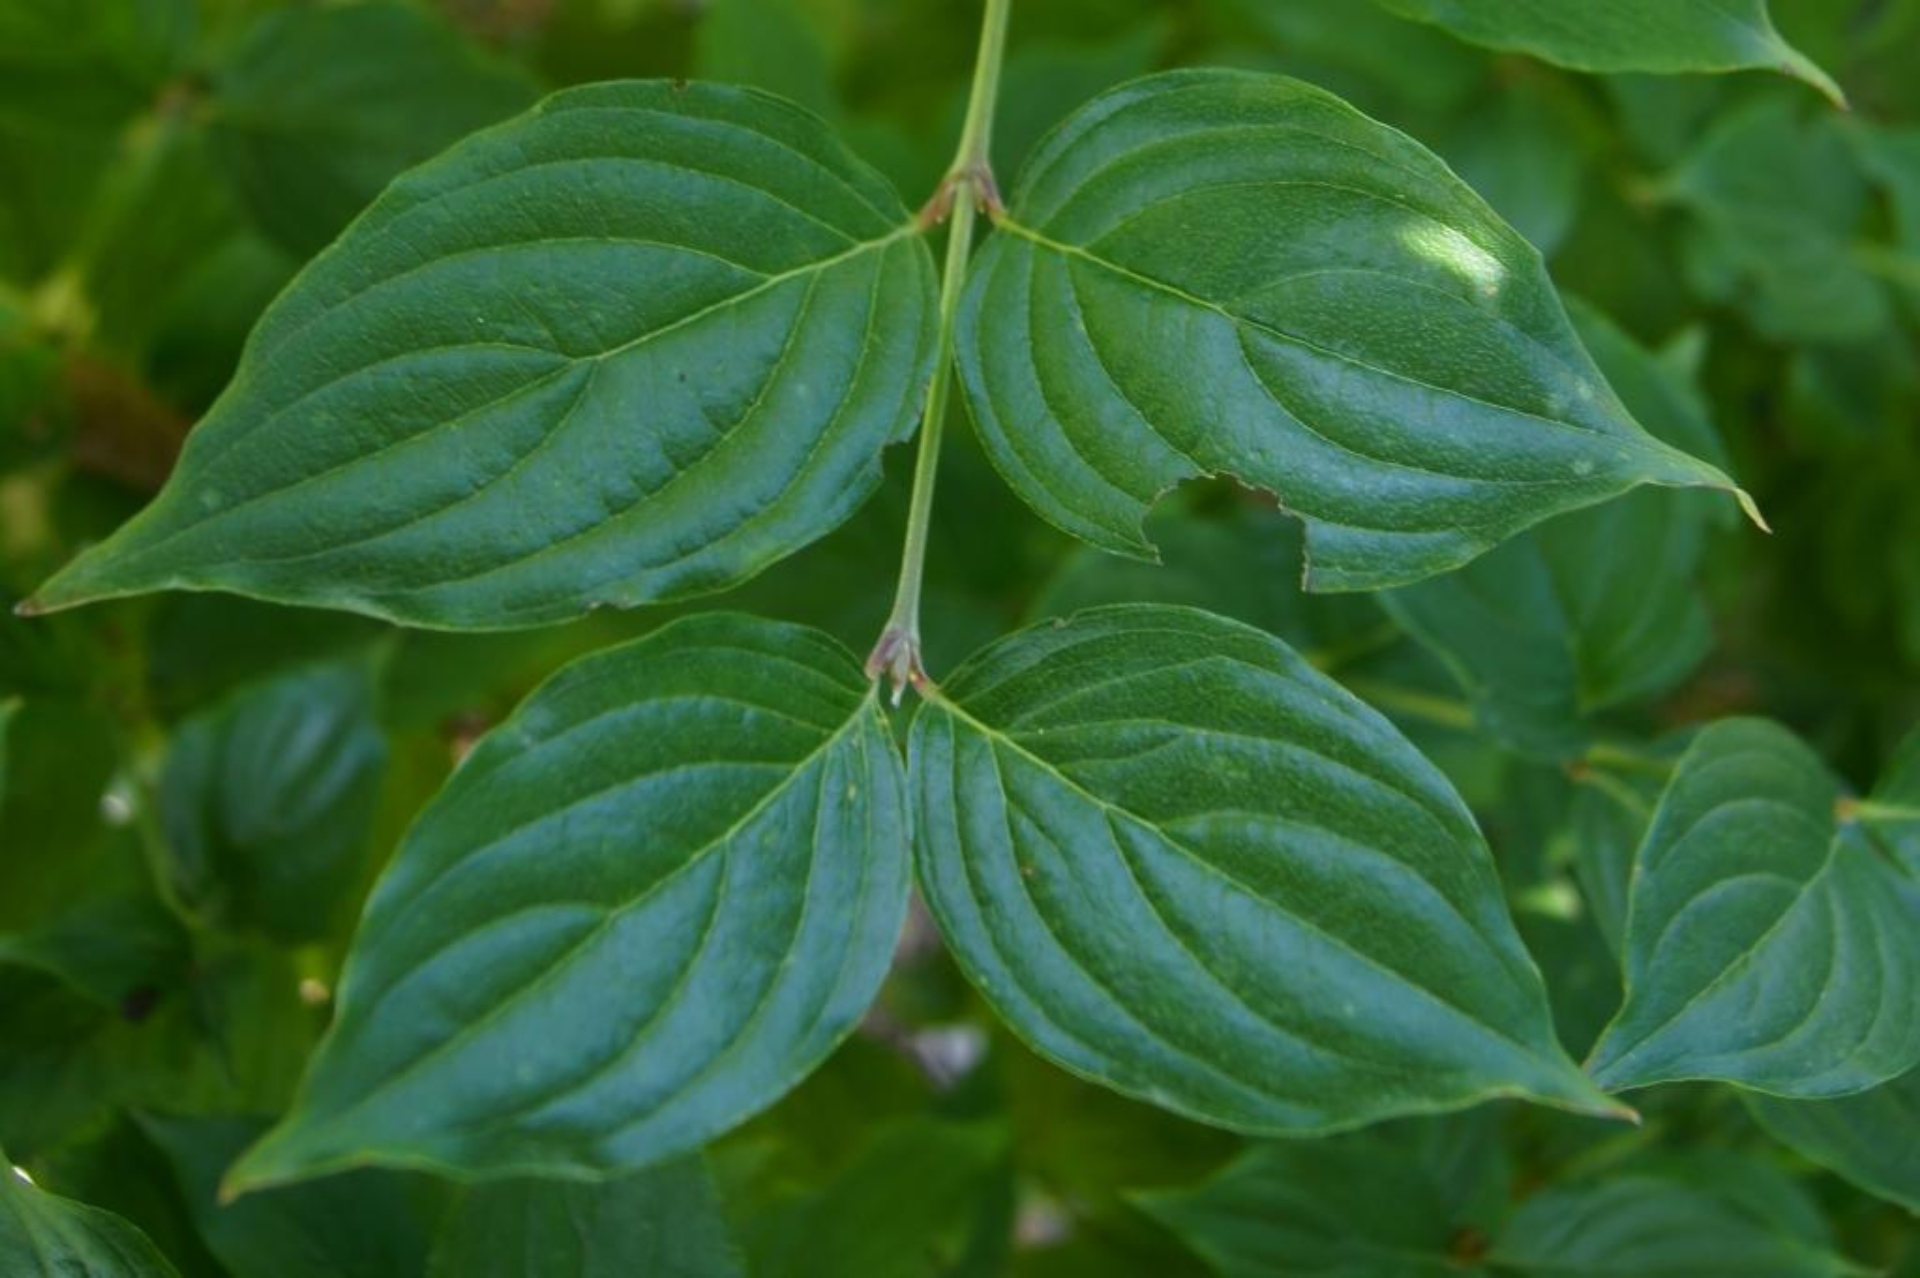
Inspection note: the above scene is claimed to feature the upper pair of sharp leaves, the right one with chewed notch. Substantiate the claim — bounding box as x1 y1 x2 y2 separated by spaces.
29 71 1732 629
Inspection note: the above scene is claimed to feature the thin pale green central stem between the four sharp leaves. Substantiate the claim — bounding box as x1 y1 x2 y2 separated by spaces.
866 0 1012 704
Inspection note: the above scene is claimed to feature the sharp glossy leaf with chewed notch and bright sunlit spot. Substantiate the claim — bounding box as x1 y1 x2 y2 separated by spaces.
956 71 1732 589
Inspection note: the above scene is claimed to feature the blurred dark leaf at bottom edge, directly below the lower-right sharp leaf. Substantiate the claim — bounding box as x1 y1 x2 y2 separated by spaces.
1135 1112 1496 1278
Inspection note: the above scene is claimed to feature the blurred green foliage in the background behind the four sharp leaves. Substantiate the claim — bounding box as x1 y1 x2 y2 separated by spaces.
0 0 1920 1278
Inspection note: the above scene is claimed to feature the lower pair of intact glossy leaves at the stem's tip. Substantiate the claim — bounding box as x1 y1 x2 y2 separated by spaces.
230 606 1617 1188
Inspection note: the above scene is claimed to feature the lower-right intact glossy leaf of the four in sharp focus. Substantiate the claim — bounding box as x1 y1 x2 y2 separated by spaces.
910 606 1609 1134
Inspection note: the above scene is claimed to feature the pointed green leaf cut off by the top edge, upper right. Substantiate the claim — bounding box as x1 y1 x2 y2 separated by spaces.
1379 0 1845 106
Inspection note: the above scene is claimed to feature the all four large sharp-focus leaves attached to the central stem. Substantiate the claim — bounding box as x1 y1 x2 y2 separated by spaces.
18 71 1781 1186
